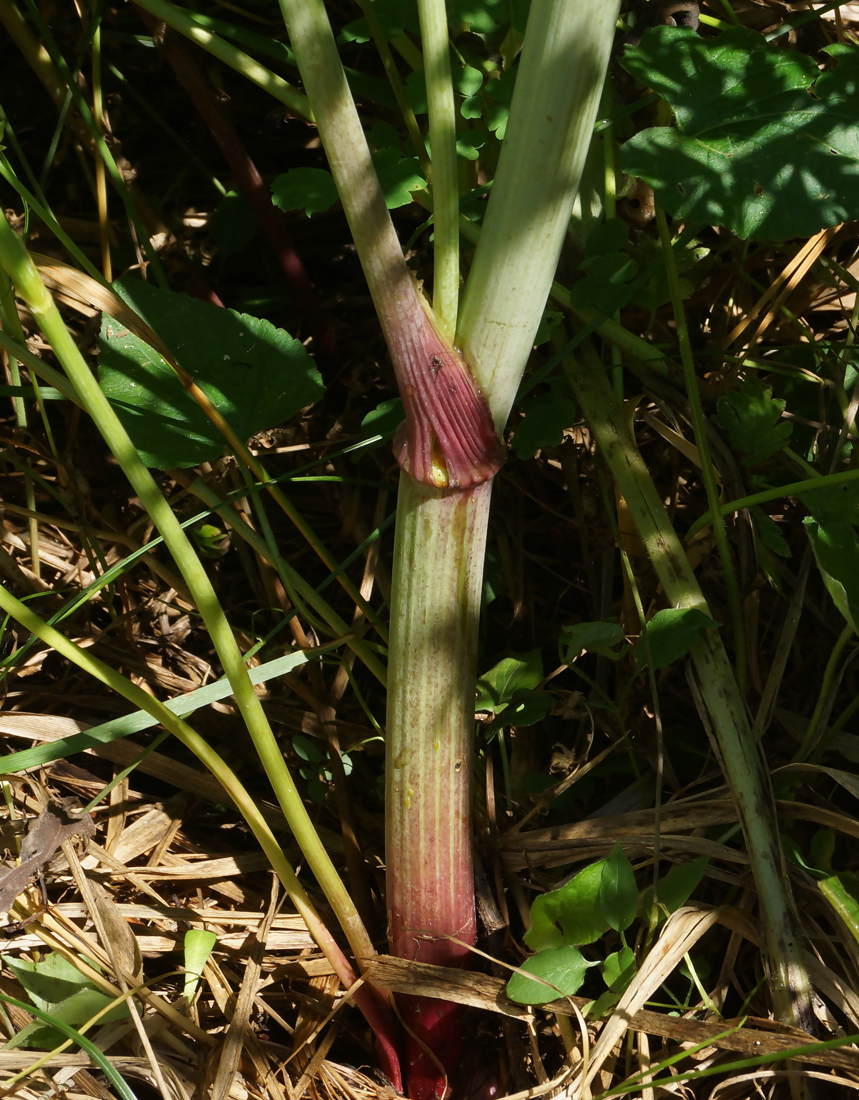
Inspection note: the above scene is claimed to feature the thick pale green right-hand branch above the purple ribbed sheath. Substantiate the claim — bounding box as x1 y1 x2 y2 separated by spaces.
456 0 618 430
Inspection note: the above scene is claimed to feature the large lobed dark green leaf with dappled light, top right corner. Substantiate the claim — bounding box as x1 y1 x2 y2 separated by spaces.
620 26 859 240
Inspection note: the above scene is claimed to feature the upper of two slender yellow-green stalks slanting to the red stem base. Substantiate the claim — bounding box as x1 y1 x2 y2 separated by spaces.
0 218 374 972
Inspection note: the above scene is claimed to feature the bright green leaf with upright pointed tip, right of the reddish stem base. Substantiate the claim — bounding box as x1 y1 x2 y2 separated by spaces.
522 859 609 952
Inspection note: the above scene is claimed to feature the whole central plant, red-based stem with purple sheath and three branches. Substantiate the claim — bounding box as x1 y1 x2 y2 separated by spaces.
280 0 617 1100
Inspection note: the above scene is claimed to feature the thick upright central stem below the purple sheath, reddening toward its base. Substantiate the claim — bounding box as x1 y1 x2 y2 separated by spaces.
385 474 492 1100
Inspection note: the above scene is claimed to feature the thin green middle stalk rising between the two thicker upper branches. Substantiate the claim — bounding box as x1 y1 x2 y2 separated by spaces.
418 0 460 339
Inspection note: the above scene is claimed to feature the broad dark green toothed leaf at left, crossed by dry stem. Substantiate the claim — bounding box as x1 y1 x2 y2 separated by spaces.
99 278 323 470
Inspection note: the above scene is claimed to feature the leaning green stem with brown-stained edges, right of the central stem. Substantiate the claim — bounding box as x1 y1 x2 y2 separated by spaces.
568 356 814 1031
